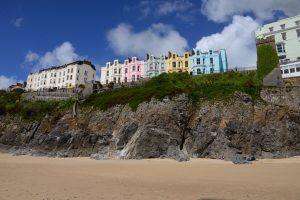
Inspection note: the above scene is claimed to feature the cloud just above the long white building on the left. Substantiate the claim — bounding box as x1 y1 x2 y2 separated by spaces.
23 42 81 72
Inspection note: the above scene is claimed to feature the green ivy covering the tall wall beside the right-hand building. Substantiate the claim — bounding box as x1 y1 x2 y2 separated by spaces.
257 45 279 80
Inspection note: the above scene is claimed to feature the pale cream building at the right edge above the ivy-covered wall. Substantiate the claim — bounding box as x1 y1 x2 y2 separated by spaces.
256 15 300 64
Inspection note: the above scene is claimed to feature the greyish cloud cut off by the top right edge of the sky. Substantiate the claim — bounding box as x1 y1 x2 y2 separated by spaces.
201 0 300 22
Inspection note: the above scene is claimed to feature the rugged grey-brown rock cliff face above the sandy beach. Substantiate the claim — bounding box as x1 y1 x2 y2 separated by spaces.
0 86 300 163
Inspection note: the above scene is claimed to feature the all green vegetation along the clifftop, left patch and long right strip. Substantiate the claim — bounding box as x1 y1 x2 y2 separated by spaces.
0 72 261 120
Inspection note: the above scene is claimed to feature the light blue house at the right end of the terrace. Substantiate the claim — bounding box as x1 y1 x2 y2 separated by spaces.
190 49 228 75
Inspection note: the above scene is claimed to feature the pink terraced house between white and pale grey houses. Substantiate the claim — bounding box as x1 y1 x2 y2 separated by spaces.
122 57 144 83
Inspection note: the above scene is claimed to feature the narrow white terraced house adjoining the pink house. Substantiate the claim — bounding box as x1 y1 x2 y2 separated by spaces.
101 60 123 85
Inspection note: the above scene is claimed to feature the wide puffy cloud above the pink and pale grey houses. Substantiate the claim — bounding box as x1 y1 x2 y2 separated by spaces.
107 23 188 56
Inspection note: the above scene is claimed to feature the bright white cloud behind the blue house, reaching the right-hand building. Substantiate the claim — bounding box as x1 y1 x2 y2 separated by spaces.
196 16 259 67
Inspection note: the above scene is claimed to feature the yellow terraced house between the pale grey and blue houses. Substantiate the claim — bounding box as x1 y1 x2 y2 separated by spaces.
166 52 191 73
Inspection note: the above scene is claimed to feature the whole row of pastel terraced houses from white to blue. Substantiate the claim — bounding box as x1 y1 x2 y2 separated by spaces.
101 49 228 84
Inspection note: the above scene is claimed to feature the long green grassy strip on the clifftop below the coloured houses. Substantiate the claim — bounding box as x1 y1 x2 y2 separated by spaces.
84 72 261 110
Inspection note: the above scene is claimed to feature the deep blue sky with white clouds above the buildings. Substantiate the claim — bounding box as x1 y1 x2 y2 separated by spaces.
0 0 300 89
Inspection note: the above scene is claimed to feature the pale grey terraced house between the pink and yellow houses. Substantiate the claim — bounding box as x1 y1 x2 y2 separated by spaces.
144 54 166 78
